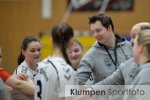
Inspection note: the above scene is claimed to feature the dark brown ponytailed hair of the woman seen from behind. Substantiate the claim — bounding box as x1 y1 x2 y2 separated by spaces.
52 23 74 65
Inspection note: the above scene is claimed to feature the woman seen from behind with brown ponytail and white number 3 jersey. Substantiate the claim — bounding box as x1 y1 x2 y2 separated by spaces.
35 23 76 100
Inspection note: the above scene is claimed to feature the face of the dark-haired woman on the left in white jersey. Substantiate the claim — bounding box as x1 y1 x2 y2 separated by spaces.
22 41 41 64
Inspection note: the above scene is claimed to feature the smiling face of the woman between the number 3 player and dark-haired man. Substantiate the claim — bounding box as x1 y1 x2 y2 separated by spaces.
67 41 83 69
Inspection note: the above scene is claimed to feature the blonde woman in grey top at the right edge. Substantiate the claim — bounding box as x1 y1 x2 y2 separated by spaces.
125 29 150 100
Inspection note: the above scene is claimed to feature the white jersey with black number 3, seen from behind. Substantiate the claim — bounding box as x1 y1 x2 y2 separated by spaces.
35 57 77 100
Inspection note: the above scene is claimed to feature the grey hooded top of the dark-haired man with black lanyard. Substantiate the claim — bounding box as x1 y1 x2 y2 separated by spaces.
77 35 132 85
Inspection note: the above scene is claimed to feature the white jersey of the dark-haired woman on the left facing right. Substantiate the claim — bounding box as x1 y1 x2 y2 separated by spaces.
13 61 36 83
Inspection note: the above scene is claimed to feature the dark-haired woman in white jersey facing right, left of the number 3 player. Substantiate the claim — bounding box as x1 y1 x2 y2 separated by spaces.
12 36 42 100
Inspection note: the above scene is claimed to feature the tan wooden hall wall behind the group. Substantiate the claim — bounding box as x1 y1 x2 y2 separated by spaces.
0 0 150 72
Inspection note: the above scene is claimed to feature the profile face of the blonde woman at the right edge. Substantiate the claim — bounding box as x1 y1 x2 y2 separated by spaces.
132 36 140 63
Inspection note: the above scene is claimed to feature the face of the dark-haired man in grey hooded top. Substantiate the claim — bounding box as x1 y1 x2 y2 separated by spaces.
91 21 110 44
